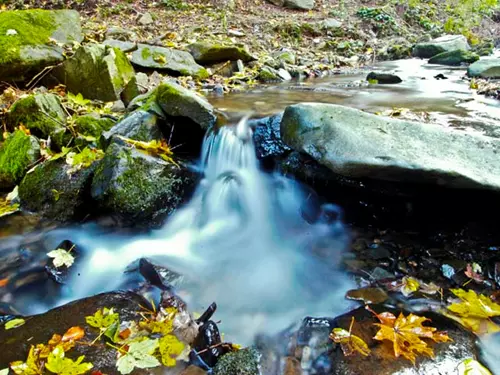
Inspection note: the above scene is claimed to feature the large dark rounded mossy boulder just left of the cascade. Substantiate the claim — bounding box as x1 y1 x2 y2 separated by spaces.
91 142 193 225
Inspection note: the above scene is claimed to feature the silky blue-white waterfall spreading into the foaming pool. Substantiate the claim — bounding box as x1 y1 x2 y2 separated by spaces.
42 120 351 344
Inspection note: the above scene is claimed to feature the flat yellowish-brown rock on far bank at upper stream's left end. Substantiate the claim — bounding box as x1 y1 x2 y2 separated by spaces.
188 43 256 64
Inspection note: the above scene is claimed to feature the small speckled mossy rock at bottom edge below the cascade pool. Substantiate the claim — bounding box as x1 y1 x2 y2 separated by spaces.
214 348 260 375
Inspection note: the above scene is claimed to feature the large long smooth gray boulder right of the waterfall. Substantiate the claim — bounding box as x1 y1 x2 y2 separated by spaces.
281 103 500 191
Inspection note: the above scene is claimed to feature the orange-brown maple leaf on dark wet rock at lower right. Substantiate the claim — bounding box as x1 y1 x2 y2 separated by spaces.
367 307 452 364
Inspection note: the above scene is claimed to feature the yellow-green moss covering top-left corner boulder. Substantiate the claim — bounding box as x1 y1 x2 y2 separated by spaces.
0 9 57 64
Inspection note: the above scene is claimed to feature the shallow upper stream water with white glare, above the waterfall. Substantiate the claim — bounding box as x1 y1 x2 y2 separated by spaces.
209 59 500 137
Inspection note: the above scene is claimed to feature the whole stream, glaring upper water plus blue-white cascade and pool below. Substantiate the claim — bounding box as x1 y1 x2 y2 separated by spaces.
0 59 500 374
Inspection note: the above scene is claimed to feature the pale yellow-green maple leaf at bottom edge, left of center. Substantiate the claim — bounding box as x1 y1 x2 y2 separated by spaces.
116 339 161 375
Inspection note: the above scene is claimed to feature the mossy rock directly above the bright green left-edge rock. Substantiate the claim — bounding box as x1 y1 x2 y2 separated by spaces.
7 94 71 148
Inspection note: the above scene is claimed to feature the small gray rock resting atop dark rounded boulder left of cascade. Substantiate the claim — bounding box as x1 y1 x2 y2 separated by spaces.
99 110 163 149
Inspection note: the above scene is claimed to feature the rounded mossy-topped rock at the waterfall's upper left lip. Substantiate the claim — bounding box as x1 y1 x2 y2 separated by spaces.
156 82 217 129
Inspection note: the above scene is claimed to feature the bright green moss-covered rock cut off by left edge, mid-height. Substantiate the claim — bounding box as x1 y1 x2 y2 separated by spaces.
0 130 40 191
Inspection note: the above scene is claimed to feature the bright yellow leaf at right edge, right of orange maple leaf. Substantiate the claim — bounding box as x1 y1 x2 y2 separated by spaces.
446 289 500 334
